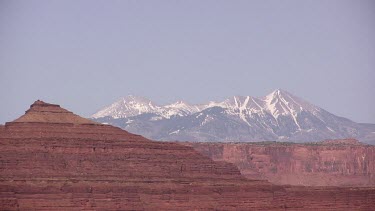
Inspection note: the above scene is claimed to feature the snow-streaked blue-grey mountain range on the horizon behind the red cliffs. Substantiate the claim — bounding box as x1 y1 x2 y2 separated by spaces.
92 89 375 142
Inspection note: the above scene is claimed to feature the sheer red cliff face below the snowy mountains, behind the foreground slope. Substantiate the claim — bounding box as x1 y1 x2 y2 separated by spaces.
188 140 375 186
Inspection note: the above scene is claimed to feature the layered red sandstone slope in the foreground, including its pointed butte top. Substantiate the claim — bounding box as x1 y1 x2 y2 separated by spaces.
0 101 375 210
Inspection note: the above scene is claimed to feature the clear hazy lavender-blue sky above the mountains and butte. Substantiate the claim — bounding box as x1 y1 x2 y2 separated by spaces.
0 0 375 124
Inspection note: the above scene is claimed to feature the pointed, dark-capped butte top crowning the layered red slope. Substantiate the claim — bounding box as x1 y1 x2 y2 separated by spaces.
13 100 99 125
